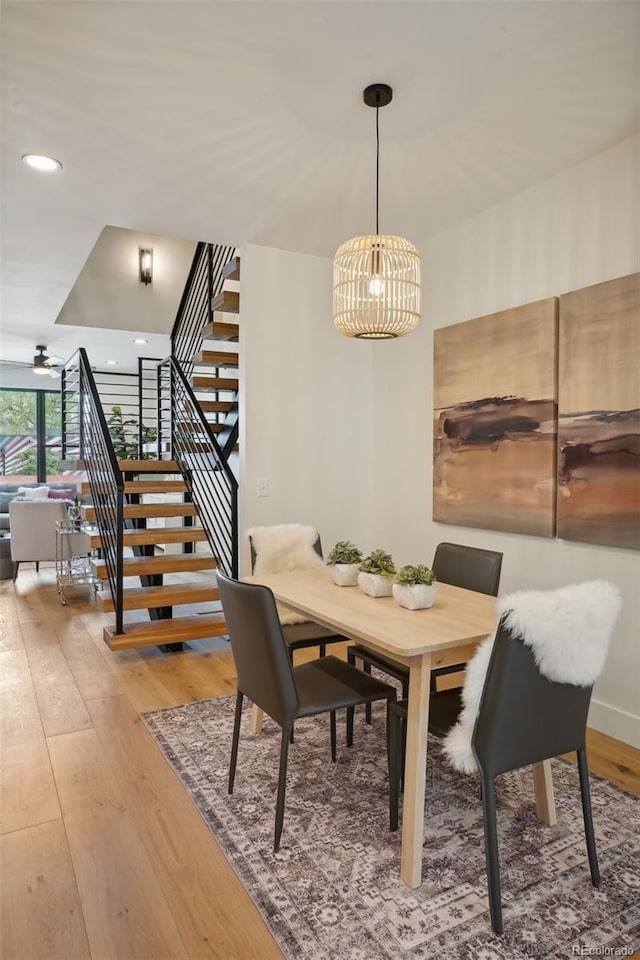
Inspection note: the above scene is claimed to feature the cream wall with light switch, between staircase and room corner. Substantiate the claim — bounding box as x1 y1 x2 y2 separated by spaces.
239 245 372 572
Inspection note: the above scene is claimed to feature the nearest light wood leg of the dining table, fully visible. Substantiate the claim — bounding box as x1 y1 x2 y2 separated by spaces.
400 653 431 889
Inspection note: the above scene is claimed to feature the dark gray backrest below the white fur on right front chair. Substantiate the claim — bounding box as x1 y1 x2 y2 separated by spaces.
472 622 593 777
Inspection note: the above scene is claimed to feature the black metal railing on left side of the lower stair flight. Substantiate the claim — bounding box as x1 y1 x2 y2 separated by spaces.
61 347 124 633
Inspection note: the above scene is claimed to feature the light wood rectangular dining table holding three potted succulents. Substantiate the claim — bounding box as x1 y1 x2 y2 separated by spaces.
243 568 555 888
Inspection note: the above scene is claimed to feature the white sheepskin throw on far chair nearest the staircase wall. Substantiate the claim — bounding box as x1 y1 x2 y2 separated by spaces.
247 523 324 624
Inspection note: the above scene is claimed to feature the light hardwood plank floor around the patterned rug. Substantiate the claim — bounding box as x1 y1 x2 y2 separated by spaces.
0 566 640 960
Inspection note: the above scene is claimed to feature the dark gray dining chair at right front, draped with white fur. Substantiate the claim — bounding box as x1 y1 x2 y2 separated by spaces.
387 581 620 934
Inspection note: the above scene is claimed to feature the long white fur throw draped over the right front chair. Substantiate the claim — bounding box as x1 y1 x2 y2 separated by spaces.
443 580 622 773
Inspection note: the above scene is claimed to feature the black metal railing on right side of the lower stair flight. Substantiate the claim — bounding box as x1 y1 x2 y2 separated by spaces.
158 357 238 577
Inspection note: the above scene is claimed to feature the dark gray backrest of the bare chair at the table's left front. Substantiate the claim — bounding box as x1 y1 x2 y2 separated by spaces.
216 571 299 727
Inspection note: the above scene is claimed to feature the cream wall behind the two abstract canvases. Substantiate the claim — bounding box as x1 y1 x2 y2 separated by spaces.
371 137 640 747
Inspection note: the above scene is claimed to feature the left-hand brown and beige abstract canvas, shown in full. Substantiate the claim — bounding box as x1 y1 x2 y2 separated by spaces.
433 297 558 537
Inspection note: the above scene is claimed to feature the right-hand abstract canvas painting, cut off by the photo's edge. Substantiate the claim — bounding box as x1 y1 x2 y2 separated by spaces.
558 273 640 549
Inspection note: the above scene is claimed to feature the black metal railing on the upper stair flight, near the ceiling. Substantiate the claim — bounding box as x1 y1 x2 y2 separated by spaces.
171 242 235 377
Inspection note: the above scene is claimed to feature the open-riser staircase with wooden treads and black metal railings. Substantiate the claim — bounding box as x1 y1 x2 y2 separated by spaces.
62 244 240 650
